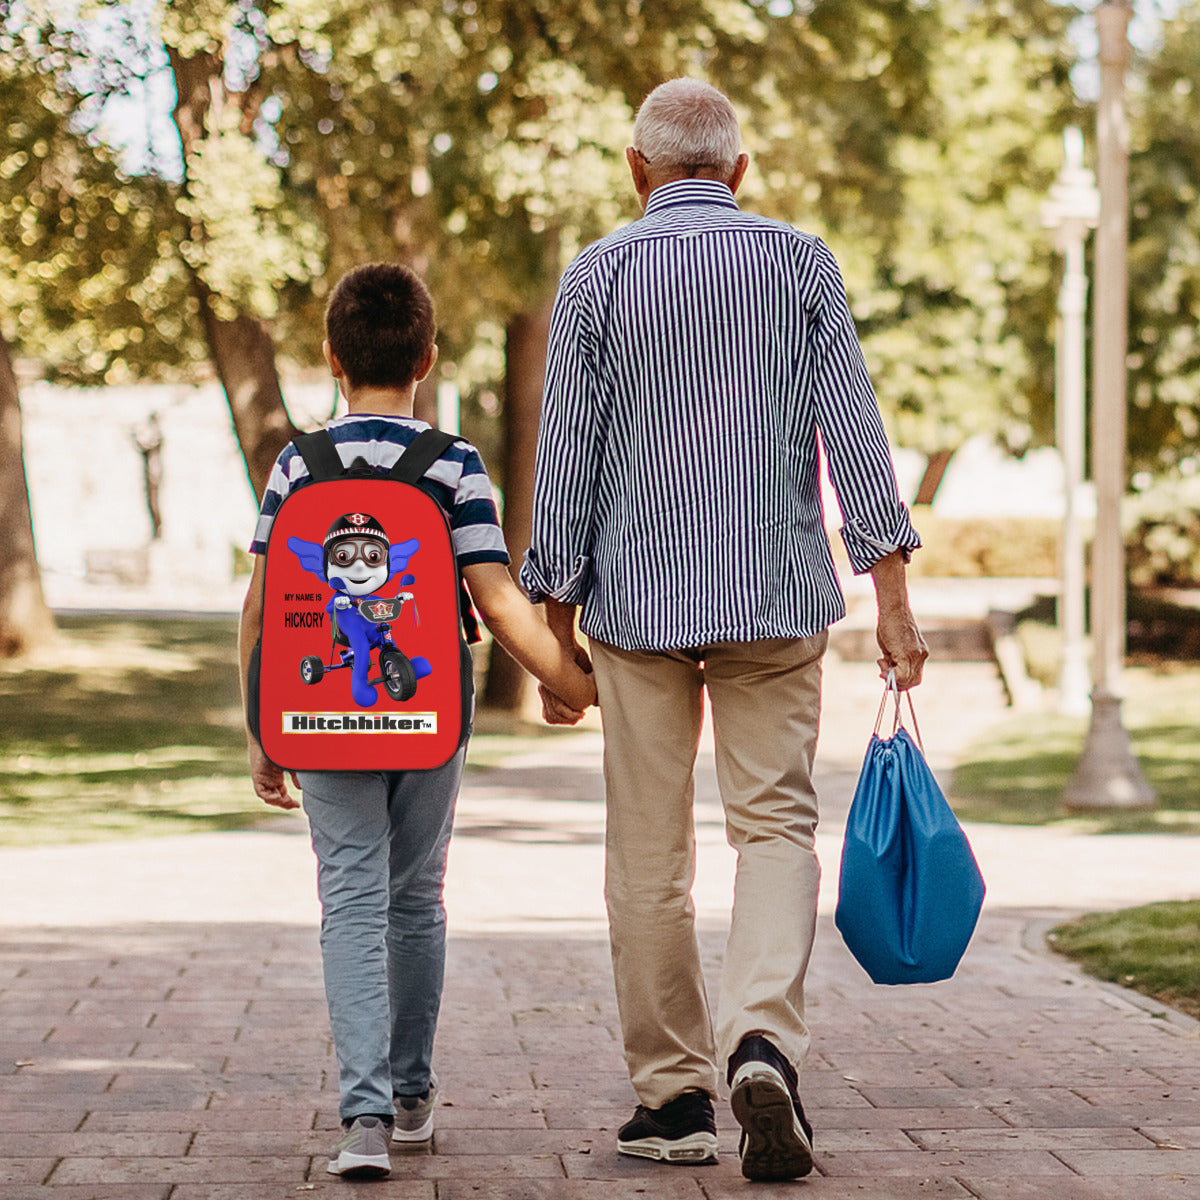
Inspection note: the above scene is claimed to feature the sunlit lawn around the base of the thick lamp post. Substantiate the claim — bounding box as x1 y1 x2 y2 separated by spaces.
949 665 1200 834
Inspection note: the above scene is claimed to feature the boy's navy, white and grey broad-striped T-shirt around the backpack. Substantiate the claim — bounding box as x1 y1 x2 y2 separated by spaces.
250 413 509 566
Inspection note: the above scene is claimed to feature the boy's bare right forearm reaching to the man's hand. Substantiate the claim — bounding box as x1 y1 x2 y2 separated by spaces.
462 563 596 712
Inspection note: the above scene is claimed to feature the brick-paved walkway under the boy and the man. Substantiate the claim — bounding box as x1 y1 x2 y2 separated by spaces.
0 661 1200 1200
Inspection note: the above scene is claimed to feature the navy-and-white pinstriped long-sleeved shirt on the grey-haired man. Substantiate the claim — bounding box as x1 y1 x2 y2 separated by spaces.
521 180 920 650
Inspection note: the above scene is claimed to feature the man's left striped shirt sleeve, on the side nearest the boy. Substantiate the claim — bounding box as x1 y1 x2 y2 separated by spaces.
521 277 596 605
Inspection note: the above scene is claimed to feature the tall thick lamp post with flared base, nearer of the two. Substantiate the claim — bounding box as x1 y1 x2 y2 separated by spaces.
1063 0 1154 810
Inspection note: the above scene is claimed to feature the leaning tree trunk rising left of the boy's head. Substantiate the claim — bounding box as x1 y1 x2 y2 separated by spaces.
168 47 300 499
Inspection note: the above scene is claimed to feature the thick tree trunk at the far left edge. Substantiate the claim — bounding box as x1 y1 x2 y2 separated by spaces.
0 336 54 659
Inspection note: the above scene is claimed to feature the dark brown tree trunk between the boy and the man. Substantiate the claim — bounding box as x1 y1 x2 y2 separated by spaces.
484 299 553 712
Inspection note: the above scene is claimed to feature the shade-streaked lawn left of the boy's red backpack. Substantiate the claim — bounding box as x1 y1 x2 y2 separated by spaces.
0 617 267 846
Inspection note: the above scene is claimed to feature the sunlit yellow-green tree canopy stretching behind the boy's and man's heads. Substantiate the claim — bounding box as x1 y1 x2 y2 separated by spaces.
0 0 1123 463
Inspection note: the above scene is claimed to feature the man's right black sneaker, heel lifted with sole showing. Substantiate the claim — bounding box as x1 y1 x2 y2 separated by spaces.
728 1033 812 1181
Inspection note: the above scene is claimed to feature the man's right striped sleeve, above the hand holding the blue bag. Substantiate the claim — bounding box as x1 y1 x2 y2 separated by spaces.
812 241 920 575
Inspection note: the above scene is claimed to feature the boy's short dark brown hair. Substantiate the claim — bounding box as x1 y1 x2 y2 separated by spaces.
325 263 437 388
